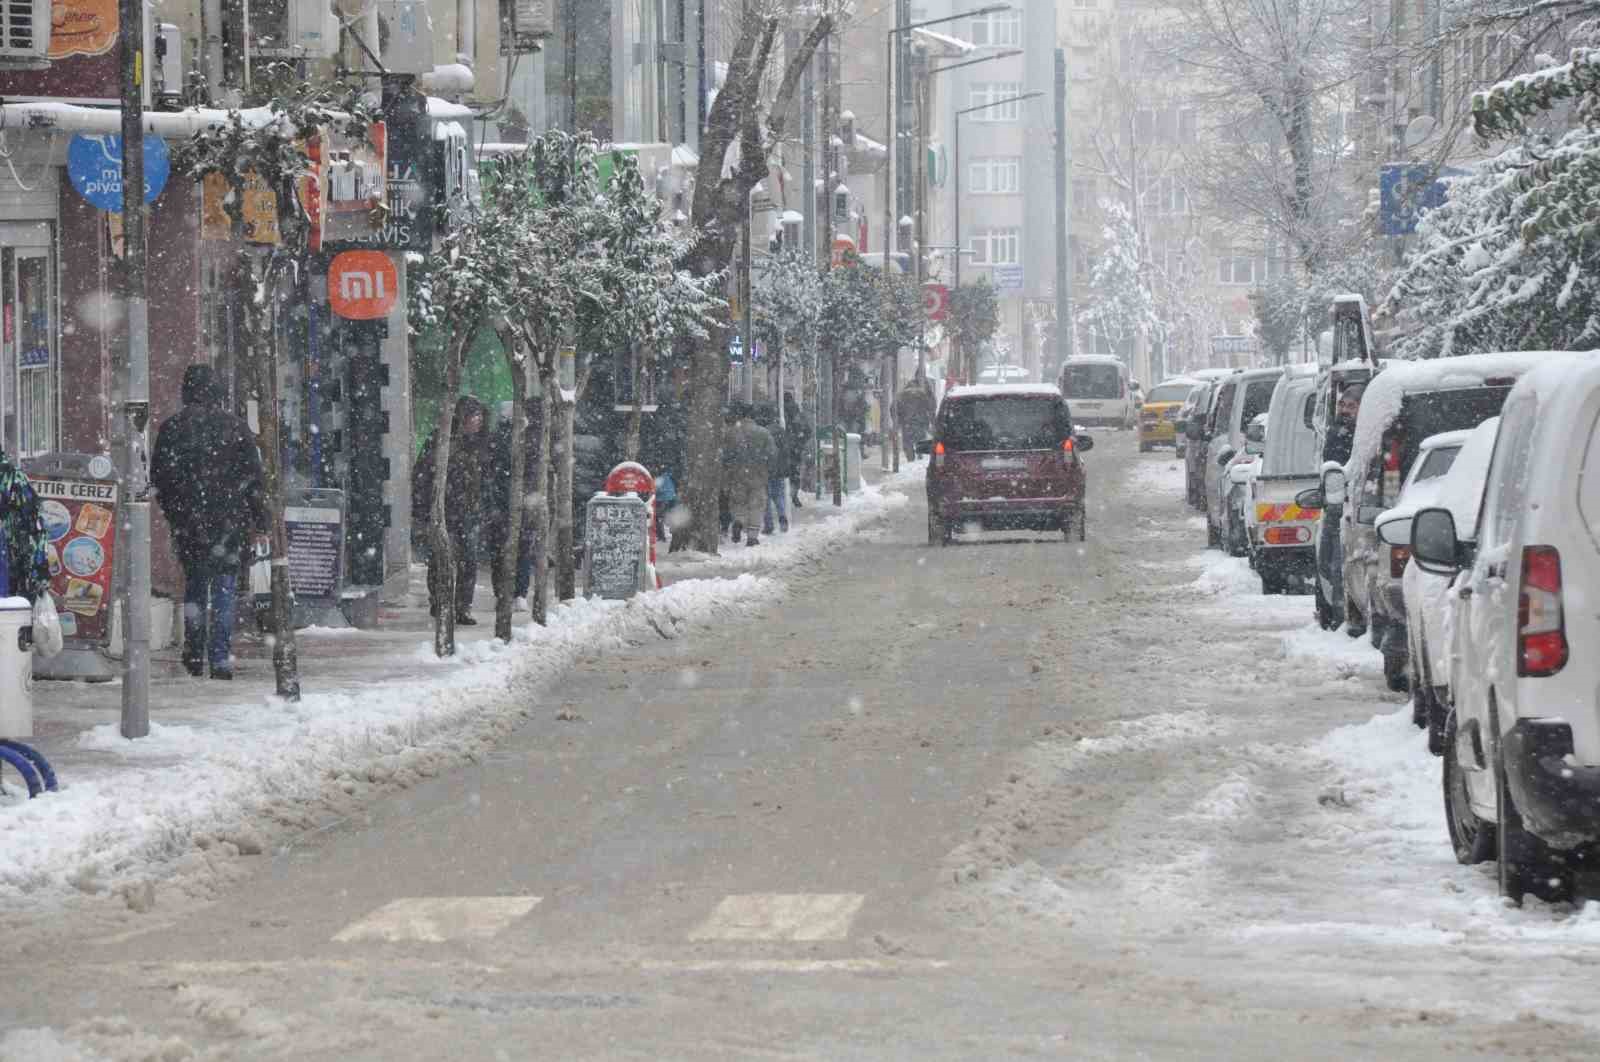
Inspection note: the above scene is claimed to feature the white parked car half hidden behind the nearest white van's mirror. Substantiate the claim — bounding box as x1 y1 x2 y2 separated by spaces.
1378 417 1499 757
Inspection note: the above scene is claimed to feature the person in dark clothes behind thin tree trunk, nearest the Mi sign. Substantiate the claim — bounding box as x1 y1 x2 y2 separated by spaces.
411 395 486 627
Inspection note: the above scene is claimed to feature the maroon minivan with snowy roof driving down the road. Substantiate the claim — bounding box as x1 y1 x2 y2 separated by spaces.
925 384 1094 545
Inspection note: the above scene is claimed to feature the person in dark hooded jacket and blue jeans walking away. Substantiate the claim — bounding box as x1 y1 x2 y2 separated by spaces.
150 365 267 678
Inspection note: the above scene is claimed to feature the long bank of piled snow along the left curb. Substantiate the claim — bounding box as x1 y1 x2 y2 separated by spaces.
0 477 906 907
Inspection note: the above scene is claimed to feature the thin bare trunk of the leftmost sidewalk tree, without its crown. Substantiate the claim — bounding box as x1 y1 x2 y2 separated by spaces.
250 266 301 701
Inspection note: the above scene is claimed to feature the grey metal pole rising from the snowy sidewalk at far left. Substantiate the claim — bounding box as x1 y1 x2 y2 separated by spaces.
118 0 150 737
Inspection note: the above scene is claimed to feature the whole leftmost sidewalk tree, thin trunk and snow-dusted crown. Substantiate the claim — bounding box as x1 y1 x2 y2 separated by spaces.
174 66 376 701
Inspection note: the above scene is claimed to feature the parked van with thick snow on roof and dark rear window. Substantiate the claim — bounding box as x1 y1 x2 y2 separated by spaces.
1323 353 1549 671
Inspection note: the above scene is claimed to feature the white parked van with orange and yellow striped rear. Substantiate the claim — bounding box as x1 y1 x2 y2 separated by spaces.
1245 368 1322 593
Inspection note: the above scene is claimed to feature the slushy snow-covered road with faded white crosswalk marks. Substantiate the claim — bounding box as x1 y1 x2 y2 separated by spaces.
0 433 1600 1059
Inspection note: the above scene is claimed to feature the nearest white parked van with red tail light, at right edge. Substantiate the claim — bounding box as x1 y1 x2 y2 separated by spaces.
1411 353 1600 902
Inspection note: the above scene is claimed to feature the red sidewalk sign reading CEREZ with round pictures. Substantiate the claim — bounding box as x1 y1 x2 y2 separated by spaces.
29 457 117 645
